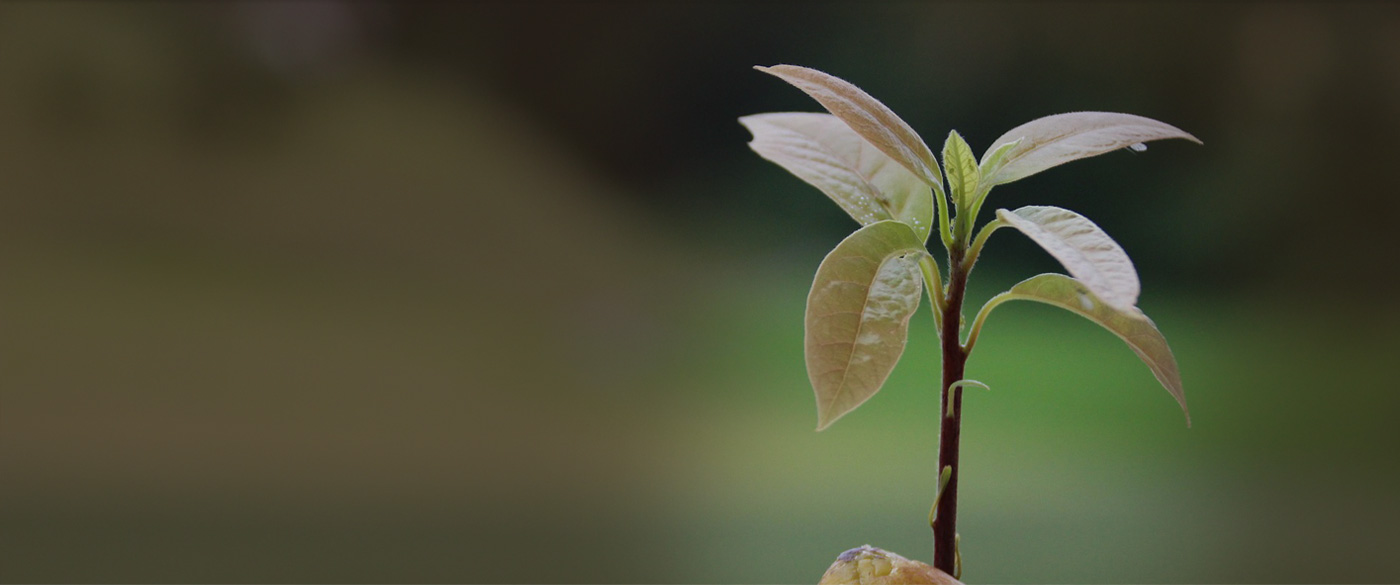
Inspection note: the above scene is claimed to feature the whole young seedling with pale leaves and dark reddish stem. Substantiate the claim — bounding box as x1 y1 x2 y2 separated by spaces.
739 64 1200 577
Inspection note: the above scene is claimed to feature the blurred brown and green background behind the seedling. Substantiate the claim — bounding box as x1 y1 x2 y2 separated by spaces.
0 1 1400 582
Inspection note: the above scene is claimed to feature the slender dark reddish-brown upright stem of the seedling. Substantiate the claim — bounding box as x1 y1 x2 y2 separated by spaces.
934 239 967 575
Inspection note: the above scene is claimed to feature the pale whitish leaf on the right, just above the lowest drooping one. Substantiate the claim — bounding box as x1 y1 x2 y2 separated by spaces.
997 206 1142 311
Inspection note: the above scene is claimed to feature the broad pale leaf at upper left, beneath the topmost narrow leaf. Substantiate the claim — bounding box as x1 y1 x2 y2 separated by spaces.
739 112 934 242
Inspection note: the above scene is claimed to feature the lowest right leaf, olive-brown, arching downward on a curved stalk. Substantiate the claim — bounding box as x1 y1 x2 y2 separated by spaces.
967 274 1191 427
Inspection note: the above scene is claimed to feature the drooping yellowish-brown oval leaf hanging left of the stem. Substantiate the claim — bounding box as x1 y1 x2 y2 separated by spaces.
806 221 928 431
